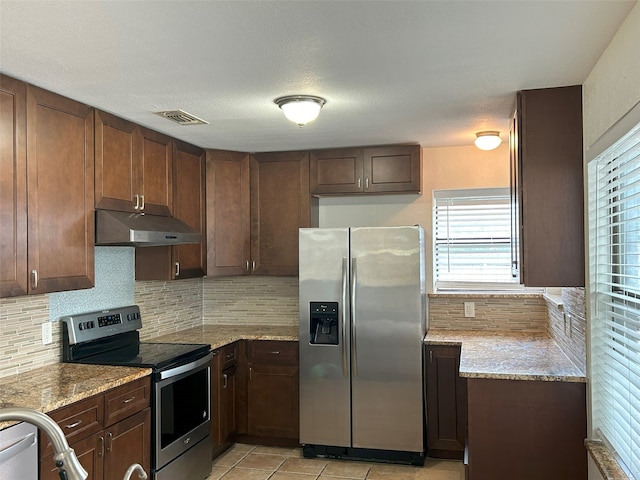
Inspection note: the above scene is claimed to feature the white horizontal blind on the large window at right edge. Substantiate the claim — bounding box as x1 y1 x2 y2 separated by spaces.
588 117 640 480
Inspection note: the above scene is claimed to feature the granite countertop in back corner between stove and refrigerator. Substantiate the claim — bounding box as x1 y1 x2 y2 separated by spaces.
151 325 299 349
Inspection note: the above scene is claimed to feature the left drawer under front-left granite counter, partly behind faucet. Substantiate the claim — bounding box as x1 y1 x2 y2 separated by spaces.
39 395 104 458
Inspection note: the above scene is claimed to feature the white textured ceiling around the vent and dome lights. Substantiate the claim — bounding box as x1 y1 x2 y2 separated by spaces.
0 0 636 152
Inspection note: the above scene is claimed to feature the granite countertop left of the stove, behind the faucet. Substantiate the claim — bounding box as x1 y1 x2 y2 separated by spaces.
0 363 151 430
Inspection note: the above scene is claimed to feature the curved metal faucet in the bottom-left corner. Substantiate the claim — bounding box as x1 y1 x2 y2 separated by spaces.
0 407 88 480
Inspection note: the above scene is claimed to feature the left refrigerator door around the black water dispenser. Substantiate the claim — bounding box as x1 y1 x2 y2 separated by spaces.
299 228 351 447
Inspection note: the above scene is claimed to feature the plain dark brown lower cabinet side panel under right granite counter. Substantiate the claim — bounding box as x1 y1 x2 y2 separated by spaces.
468 378 587 480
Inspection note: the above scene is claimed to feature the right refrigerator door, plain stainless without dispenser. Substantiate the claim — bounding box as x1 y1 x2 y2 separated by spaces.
351 227 425 452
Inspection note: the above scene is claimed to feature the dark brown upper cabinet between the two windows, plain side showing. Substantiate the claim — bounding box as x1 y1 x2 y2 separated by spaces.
510 85 585 287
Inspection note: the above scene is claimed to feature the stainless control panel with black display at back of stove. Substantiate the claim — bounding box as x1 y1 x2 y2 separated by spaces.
61 305 142 345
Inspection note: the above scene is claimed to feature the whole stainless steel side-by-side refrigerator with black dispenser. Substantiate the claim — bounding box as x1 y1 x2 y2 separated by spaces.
299 226 426 465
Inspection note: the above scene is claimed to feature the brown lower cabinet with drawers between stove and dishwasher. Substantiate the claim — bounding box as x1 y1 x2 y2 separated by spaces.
39 377 151 480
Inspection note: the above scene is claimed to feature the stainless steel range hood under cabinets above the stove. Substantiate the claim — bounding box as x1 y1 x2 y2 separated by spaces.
96 210 201 247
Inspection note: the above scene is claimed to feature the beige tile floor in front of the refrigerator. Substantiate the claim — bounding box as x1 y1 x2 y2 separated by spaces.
207 443 464 480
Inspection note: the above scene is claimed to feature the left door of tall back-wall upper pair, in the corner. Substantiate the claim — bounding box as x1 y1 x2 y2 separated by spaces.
206 150 251 276
